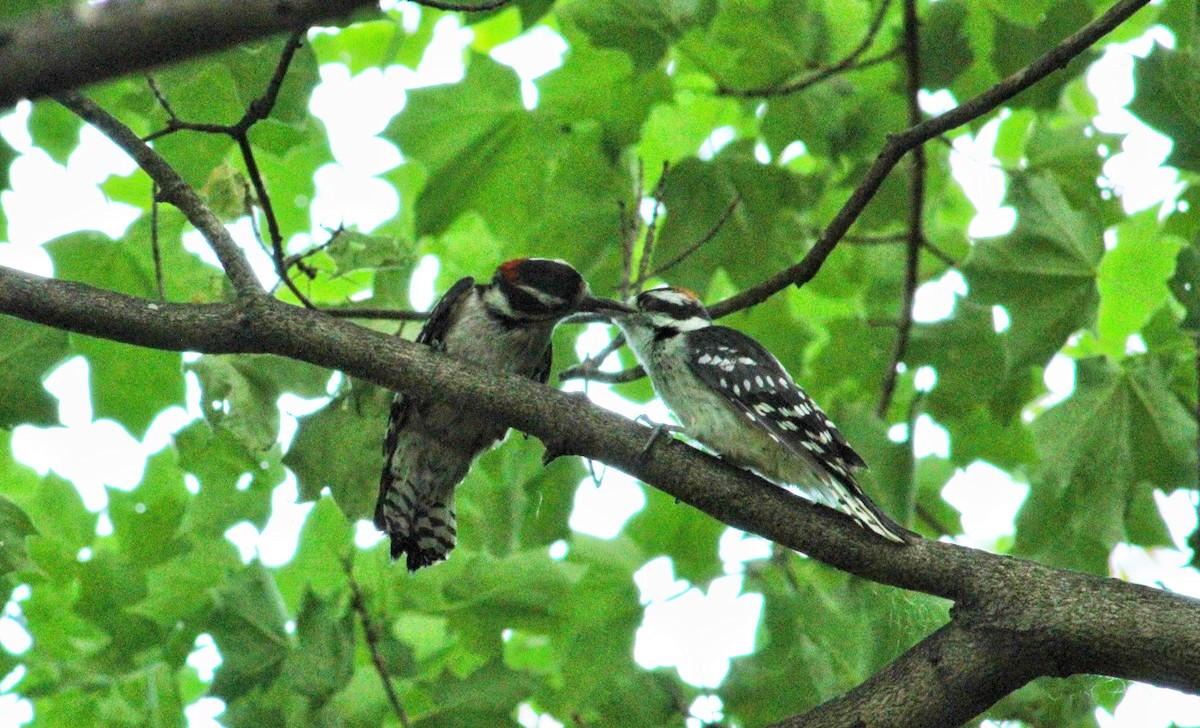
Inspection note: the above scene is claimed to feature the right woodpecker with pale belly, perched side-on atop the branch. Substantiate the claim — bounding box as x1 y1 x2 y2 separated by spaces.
611 288 911 543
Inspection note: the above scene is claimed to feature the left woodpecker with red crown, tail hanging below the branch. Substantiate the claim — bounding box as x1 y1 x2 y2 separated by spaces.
374 258 630 571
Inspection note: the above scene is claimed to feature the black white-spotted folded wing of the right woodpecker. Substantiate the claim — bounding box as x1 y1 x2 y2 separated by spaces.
688 326 866 477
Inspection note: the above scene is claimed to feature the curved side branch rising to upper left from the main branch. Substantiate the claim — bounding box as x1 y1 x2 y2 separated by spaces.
58 94 264 296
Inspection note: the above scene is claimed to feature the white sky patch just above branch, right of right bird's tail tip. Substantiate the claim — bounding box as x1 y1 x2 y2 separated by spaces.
942 461 1030 549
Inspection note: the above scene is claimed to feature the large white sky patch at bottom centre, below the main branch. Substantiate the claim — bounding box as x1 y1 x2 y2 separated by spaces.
634 574 762 687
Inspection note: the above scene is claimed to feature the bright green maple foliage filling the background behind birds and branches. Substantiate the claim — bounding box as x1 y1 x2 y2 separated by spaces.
0 0 1200 728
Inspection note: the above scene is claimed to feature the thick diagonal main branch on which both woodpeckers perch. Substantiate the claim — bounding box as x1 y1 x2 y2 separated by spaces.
0 261 1200 726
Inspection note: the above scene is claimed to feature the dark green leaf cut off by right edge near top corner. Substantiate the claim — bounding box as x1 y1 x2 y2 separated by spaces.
1129 44 1200 172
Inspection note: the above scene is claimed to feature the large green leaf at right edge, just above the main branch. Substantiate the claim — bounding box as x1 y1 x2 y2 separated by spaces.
1015 357 1196 573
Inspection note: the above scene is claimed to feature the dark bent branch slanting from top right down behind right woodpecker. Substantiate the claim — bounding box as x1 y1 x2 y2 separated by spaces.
709 0 1150 317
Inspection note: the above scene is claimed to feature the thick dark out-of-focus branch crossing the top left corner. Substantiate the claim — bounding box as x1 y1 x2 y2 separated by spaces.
0 0 378 108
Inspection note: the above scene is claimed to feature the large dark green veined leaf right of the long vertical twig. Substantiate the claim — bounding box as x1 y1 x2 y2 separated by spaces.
962 175 1104 368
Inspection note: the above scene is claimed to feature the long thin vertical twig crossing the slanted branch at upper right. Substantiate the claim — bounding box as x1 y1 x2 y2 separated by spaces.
875 0 925 419
